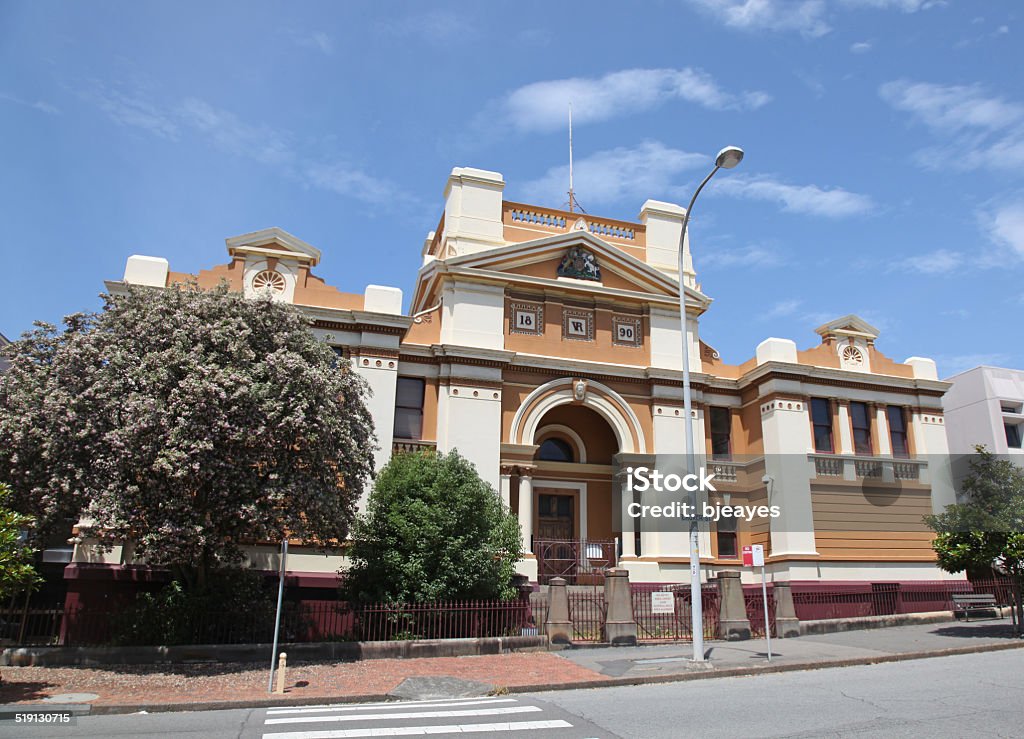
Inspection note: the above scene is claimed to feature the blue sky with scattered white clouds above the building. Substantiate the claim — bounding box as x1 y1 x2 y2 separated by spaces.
0 0 1024 376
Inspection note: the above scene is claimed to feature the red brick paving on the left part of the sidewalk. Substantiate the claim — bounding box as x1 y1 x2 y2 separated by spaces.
0 652 608 705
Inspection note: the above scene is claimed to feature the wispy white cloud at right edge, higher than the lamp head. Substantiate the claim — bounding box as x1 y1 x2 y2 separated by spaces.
879 80 1024 172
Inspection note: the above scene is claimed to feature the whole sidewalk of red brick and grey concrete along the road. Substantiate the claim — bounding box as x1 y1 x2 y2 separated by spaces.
0 620 1024 713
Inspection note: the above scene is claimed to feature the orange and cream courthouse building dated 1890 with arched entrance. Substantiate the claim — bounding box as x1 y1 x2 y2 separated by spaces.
76 168 954 583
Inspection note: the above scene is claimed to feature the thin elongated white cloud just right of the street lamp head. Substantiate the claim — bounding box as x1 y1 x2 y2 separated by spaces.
712 175 874 218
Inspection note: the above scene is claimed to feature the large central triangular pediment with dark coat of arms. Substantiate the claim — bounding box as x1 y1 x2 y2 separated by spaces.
445 230 710 303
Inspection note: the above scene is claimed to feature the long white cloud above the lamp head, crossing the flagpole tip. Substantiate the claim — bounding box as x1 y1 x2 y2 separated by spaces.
493 68 771 131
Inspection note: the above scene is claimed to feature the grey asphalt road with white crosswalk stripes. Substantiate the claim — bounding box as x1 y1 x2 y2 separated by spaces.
0 650 1024 739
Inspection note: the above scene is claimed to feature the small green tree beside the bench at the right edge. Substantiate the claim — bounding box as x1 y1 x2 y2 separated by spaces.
926 446 1024 635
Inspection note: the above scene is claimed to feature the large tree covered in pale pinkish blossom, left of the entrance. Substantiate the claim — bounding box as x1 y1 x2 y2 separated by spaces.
0 284 375 589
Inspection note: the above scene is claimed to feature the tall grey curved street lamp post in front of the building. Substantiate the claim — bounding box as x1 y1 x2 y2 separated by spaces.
679 146 743 662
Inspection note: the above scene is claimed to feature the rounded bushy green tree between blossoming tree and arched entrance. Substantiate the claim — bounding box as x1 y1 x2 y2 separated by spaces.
343 451 520 602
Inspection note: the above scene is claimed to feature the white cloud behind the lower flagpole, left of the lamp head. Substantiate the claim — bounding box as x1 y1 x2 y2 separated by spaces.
522 141 709 208
